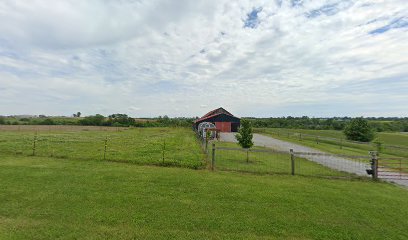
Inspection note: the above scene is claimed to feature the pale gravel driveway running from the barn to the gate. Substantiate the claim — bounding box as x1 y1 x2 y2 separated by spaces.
220 133 408 187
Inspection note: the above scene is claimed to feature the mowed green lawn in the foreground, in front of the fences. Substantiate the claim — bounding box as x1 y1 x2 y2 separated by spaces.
0 156 408 239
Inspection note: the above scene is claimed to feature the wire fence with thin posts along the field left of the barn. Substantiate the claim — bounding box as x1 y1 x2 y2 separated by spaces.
0 133 205 169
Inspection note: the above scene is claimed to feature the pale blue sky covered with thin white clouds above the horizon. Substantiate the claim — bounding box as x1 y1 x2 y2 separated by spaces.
0 0 408 117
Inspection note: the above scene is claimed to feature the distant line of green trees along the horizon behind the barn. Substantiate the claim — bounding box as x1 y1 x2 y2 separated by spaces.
0 112 408 132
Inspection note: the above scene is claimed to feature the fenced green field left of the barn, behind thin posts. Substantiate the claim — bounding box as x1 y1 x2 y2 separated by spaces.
0 128 204 168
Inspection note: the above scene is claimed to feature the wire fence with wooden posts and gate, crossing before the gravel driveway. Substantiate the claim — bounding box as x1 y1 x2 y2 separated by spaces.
211 144 408 180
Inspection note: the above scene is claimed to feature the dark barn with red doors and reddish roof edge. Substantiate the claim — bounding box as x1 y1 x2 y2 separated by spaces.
194 107 240 132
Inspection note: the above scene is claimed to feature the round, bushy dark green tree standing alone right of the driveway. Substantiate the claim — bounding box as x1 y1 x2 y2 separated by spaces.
344 117 374 142
